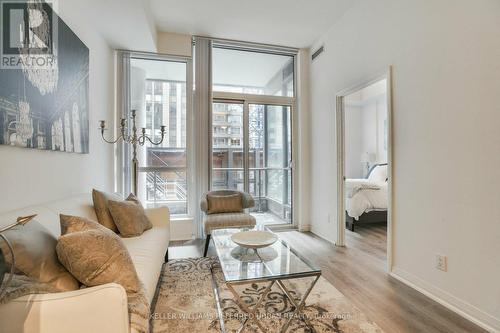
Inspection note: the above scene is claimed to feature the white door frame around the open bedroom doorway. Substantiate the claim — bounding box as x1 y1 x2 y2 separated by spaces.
335 66 394 272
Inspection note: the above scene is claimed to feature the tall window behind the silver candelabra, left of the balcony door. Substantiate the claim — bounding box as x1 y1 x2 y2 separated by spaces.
130 57 189 215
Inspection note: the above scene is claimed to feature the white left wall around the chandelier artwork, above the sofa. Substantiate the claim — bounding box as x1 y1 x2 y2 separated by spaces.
0 1 113 212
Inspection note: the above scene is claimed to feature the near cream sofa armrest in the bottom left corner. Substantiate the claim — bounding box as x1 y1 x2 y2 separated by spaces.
0 283 130 333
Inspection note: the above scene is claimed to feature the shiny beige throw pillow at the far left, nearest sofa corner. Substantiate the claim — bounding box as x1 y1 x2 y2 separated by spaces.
0 221 79 291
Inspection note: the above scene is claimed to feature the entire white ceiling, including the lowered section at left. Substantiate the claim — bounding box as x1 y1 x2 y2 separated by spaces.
58 0 361 52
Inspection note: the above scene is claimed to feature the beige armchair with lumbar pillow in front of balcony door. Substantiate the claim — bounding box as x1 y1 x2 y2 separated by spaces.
200 190 256 257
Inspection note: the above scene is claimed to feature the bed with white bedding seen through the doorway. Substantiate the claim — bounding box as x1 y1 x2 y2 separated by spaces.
345 163 388 231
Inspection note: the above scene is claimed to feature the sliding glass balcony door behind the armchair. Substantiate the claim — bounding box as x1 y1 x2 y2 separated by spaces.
211 100 292 224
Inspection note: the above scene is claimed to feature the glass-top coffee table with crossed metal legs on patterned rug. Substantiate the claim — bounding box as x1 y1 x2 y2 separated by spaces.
211 226 321 332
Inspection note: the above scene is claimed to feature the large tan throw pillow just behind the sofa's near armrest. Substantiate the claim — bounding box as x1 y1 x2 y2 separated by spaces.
56 229 140 292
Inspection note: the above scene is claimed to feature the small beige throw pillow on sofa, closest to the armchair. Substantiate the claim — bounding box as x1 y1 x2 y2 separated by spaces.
108 194 153 237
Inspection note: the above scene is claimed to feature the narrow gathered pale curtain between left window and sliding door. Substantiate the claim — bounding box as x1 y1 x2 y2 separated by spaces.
193 37 212 238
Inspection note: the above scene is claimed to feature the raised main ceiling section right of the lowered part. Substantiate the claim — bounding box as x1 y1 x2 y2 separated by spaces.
149 0 359 47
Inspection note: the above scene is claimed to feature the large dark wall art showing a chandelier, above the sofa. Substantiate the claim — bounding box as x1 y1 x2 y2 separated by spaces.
0 0 89 153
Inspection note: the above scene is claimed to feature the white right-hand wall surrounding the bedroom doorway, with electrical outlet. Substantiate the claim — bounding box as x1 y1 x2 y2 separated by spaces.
311 0 500 330
